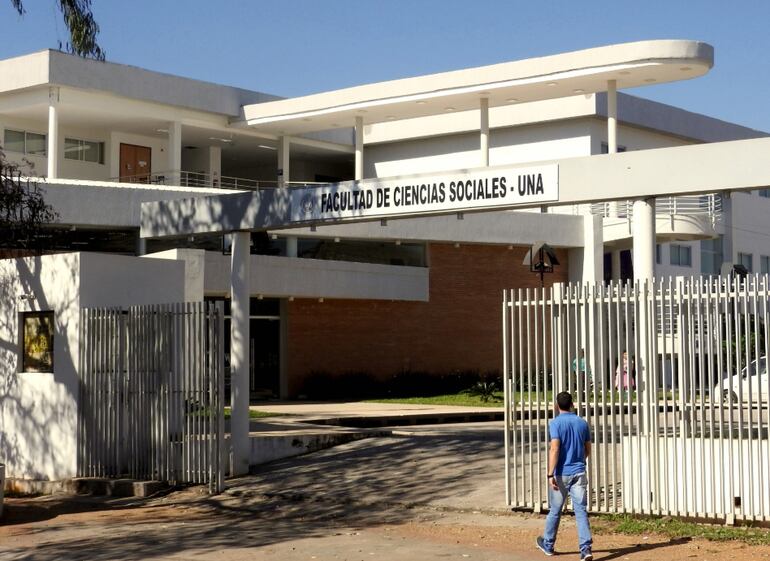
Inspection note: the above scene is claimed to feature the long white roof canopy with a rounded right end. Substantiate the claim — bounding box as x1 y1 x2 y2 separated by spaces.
243 40 714 135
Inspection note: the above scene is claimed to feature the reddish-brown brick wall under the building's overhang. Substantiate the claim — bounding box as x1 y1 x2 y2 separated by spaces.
287 244 568 395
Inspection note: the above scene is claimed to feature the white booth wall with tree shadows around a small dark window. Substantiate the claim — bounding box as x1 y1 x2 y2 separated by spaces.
0 254 80 479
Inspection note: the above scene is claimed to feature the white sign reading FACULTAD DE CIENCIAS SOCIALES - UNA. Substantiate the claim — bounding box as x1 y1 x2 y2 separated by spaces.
291 164 559 222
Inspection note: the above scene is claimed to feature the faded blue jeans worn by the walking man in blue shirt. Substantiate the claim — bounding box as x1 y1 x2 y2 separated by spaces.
543 473 593 553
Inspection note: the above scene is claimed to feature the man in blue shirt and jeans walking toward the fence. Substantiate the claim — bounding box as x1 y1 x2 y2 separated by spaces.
537 392 594 561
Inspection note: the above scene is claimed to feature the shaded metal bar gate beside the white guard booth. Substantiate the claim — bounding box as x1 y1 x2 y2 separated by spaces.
78 303 226 492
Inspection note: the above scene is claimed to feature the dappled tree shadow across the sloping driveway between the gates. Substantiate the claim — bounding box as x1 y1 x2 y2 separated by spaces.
3 428 504 561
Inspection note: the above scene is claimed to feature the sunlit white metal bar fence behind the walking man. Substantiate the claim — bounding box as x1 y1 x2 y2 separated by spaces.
503 275 770 522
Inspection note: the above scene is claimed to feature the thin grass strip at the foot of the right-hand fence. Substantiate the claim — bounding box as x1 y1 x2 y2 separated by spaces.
591 514 770 545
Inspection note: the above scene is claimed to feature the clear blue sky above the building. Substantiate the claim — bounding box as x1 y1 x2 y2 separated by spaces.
0 0 770 131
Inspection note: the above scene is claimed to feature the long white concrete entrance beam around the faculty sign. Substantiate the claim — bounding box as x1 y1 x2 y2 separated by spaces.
140 138 770 238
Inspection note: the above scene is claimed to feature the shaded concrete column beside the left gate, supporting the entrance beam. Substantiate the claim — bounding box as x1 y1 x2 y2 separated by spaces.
230 232 251 475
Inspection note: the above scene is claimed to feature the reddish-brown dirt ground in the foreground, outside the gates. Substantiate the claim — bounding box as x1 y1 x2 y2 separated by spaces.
0 490 770 561
